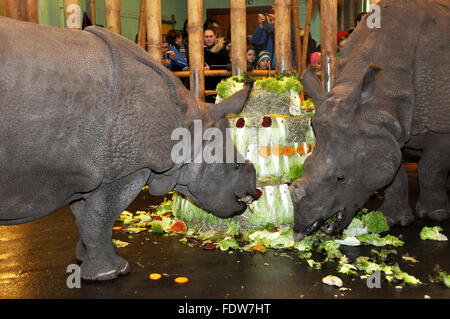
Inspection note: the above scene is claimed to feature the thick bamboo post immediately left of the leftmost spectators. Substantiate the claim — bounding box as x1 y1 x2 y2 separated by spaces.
145 0 162 62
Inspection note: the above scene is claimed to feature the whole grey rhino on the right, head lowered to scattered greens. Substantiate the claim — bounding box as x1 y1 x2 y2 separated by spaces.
290 0 450 240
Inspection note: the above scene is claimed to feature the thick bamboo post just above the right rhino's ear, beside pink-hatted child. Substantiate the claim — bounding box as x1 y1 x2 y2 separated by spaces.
320 0 337 90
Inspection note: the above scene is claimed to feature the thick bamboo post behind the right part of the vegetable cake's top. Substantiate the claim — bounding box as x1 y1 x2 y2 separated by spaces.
274 0 292 73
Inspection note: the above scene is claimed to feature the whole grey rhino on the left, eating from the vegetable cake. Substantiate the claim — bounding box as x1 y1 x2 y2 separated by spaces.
0 17 256 280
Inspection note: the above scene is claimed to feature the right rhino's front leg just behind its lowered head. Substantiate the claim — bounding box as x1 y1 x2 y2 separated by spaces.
380 165 414 226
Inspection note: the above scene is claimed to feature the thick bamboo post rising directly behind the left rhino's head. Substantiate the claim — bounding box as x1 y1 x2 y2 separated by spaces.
187 0 205 101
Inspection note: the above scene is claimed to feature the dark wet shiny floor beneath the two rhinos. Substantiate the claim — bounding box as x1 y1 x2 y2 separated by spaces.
0 164 450 299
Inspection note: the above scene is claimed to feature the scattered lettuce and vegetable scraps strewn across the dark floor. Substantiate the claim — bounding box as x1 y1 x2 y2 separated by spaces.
113 192 450 288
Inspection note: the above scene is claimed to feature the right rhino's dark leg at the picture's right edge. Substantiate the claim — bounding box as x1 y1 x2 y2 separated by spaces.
416 133 450 221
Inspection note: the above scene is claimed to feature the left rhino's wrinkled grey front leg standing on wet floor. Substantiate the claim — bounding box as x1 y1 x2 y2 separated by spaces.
70 169 150 280
